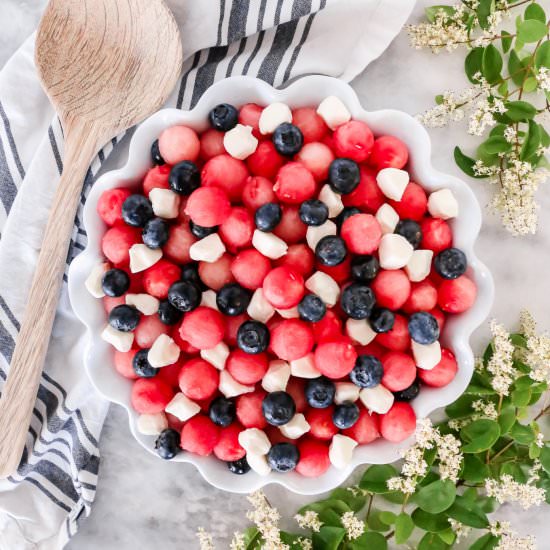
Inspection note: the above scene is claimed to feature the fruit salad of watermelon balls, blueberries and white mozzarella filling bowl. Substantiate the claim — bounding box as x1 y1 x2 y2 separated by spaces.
86 96 476 477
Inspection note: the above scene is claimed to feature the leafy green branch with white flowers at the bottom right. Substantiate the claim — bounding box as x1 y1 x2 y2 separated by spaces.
199 313 550 550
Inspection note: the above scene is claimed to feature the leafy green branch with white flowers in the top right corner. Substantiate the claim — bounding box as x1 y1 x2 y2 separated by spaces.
408 0 550 235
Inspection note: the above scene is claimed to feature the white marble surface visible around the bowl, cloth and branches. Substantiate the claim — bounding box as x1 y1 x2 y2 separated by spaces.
0 0 550 550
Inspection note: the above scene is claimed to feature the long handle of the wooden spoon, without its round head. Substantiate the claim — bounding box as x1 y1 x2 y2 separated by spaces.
0 125 98 478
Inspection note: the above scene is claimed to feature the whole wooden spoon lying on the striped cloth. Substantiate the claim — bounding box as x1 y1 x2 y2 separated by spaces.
0 0 182 477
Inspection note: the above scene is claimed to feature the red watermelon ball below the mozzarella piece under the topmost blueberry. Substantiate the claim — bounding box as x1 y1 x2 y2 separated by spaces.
202 155 249 202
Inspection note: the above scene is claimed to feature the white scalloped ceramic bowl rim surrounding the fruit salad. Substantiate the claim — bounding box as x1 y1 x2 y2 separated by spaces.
69 76 494 494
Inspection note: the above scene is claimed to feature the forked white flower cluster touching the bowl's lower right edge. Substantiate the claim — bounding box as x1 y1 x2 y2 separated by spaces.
387 418 462 494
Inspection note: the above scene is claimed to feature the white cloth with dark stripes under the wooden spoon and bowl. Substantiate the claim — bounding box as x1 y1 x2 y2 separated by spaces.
0 0 414 550
